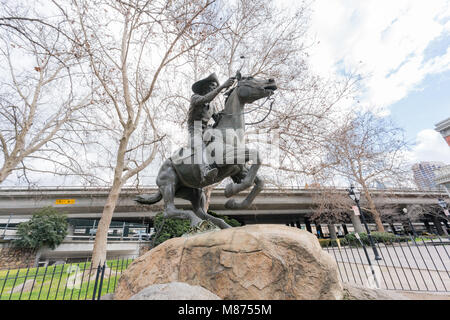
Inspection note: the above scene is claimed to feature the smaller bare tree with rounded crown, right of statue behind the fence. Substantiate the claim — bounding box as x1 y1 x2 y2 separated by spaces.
324 111 408 232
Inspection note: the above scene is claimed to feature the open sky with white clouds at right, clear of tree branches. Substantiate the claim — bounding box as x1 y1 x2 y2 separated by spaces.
310 0 450 164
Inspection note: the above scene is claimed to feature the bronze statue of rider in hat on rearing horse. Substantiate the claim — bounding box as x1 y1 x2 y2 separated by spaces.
136 72 277 229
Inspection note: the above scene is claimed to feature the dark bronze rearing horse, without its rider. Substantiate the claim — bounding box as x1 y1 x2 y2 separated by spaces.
136 77 277 229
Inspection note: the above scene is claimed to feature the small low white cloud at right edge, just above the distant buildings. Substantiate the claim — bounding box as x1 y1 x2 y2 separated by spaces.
409 129 450 164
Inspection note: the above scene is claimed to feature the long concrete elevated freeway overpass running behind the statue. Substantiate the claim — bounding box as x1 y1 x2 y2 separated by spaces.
0 187 446 224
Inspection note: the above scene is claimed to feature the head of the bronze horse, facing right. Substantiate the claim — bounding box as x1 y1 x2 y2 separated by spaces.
235 77 277 103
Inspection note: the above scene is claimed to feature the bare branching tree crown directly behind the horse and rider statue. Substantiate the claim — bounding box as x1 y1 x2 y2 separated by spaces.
163 0 356 208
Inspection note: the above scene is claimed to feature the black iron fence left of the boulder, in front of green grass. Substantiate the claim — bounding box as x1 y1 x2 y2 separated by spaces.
0 258 133 300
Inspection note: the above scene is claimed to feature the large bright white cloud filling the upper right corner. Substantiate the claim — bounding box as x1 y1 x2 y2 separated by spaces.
311 0 450 108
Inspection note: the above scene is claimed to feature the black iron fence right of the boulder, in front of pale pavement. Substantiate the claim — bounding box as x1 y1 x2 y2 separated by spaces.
322 235 450 292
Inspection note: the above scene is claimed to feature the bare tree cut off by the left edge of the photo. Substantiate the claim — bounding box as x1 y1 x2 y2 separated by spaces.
0 4 92 184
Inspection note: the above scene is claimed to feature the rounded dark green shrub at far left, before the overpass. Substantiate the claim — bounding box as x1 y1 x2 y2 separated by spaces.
13 207 68 249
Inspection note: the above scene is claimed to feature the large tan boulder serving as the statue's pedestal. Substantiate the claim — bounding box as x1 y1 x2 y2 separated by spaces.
114 225 343 300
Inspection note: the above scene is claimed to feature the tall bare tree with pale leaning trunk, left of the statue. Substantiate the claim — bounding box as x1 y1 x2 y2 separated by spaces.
55 0 229 266
